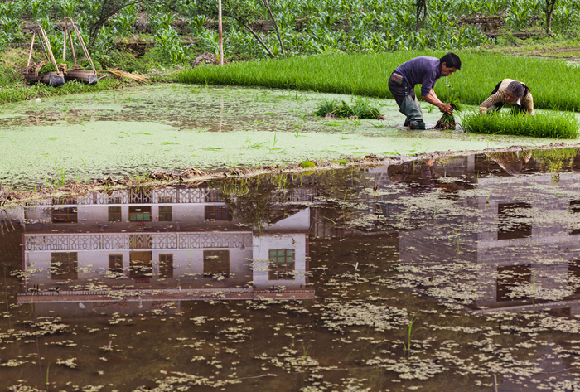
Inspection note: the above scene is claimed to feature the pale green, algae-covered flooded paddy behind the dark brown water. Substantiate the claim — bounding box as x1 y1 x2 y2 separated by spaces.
0 84 576 189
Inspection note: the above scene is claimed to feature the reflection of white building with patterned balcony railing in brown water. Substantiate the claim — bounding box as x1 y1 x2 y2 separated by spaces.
19 188 314 312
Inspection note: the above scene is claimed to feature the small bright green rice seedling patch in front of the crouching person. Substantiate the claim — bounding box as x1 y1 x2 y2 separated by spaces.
461 112 580 139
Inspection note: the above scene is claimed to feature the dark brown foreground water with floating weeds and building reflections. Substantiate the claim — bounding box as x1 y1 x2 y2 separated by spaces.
0 149 580 392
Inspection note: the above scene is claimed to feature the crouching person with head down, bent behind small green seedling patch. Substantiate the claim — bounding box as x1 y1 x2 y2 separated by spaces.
479 79 534 115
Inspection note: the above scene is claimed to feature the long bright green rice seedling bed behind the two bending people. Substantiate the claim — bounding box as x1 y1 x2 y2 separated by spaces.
176 52 580 112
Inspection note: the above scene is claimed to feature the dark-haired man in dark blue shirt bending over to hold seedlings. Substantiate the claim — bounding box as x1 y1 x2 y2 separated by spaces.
389 52 461 129
